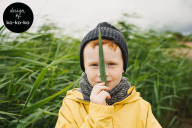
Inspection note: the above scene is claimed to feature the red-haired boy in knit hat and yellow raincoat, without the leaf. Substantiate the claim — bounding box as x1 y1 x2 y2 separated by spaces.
56 22 161 128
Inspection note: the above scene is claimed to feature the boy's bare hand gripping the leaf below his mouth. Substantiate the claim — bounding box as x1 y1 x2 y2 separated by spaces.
90 83 111 105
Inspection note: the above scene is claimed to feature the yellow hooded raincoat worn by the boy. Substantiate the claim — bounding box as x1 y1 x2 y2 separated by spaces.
55 86 161 128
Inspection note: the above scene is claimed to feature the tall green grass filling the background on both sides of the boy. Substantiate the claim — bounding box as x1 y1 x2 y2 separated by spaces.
0 15 192 128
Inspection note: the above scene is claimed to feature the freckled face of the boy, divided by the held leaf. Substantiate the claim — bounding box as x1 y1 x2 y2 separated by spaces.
83 44 124 90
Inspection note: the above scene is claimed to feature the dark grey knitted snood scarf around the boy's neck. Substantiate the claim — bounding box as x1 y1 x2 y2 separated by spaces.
79 72 131 105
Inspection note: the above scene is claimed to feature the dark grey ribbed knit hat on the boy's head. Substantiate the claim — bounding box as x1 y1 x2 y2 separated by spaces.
79 22 128 73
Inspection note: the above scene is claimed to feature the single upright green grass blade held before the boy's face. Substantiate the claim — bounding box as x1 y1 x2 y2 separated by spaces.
99 26 107 86
